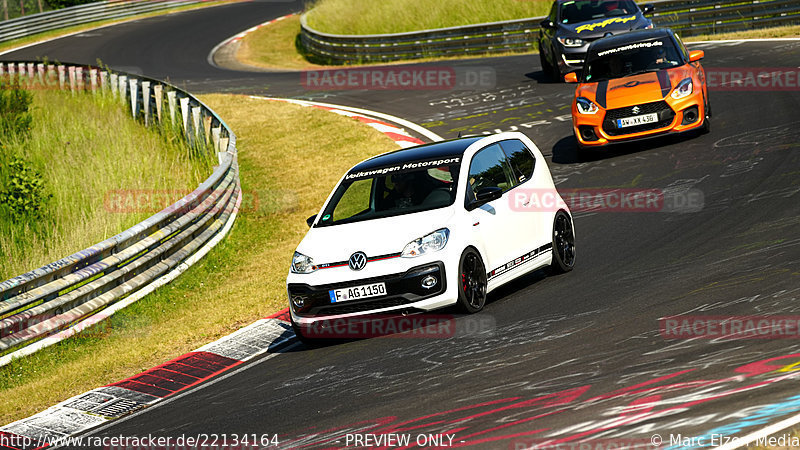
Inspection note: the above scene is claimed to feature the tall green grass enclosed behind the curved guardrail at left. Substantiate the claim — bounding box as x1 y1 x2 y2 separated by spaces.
0 90 216 279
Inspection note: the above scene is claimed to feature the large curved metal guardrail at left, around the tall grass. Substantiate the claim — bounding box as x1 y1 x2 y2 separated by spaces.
0 62 241 366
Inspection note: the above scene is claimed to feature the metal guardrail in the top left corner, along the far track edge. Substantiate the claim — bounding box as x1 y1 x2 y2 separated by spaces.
0 0 200 42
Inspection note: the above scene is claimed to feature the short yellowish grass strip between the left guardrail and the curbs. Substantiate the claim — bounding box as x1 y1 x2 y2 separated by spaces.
0 95 396 424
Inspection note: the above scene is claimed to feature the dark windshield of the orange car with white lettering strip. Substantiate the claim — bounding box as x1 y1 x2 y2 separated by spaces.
584 39 683 82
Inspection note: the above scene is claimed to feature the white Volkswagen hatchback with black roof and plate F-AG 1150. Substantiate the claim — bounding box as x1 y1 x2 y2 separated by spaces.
286 133 575 340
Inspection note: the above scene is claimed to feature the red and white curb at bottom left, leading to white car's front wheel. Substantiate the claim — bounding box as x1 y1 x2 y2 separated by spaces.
0 310 294 450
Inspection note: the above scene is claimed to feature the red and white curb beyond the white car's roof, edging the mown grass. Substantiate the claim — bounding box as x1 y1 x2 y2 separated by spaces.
250 95 442 148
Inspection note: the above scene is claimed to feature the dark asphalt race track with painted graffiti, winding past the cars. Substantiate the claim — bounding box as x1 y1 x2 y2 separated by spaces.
0 1 800 448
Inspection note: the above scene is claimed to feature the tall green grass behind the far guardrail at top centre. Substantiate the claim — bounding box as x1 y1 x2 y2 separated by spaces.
307 0 552 34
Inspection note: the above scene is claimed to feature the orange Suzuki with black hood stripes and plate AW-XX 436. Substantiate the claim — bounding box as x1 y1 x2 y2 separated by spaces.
564 28 711 149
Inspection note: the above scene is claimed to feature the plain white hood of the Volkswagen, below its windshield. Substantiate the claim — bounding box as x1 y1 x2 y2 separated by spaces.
297 206 454 264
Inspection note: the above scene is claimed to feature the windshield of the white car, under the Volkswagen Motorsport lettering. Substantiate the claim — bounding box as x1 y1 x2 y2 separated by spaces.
317 157 461 226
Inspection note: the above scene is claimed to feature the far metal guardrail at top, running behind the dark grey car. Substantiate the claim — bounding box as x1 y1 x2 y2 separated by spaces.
300 0 800 64
